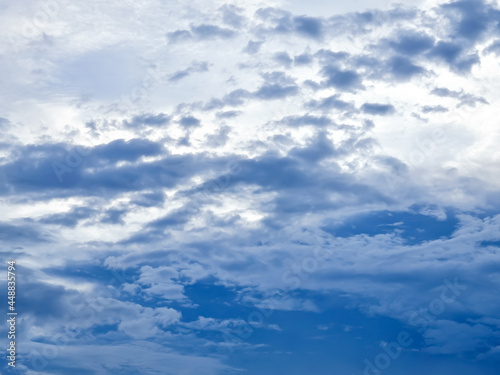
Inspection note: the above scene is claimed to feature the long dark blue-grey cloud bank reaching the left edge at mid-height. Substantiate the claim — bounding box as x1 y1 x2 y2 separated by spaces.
0 141 222 199
